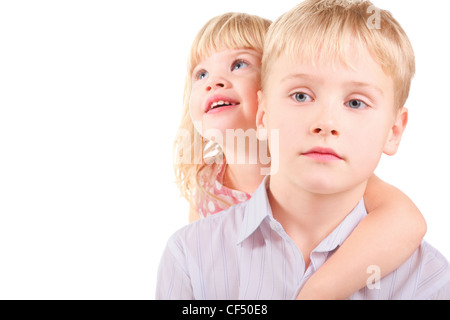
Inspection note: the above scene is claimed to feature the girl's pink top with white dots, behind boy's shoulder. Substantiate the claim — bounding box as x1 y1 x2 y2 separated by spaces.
194 163 251 218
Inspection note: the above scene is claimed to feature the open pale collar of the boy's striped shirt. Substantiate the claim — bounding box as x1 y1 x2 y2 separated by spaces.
237 176 367 252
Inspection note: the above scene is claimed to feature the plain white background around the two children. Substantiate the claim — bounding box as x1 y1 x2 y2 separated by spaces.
0 0 450 299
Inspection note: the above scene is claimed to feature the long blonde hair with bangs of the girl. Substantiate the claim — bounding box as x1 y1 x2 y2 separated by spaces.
174 12 271 205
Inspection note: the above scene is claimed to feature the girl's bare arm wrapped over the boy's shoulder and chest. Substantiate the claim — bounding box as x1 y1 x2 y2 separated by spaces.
297 175 427 299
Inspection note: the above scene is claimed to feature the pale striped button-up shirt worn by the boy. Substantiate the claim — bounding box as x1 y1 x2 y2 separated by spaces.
156 178 450 300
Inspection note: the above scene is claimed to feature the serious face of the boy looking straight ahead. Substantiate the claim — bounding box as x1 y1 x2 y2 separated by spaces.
257 45 407 194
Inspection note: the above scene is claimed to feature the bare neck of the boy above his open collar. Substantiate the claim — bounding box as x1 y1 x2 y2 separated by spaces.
268 176 367 268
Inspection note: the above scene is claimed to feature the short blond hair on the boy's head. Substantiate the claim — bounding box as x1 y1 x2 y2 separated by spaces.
261 0 415 110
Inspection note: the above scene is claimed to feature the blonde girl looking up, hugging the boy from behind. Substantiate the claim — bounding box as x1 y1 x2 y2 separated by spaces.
174 13 426 299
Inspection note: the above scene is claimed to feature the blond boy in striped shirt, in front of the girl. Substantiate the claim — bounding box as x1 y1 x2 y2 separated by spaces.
157 0 450 299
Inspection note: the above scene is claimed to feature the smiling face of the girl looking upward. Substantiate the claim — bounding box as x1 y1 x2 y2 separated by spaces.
189 49 261 146
